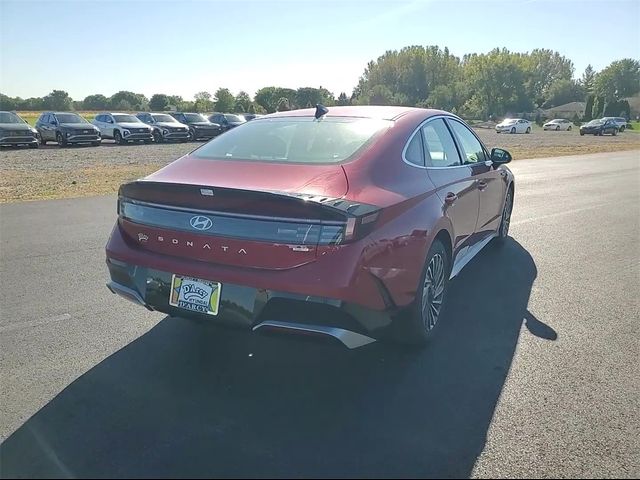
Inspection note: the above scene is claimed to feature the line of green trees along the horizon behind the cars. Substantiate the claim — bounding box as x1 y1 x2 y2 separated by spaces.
0 46 640 120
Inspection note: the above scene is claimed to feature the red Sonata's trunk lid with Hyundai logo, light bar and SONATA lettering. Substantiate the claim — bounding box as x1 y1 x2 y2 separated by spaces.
118 157 350 270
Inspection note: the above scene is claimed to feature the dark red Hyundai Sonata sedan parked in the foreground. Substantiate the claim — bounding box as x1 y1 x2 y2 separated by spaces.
106 105 514 348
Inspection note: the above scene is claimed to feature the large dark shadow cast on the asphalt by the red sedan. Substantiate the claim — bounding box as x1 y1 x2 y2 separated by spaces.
0 239 557 478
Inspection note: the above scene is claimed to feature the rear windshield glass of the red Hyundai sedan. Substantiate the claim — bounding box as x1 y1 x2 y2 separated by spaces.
193 117 393 163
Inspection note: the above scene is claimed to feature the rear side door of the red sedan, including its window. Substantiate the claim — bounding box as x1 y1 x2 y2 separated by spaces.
420 118 479 256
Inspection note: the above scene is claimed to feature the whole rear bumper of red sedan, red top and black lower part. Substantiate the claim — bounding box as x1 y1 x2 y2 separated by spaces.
106 225 403 338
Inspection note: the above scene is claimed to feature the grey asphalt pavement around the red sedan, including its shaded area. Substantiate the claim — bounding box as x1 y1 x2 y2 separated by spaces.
0 150 640 478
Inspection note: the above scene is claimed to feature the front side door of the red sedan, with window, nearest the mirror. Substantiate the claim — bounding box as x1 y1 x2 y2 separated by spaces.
448 119 505 243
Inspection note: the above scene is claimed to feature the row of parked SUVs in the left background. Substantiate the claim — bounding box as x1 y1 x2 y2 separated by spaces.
0 112 259 148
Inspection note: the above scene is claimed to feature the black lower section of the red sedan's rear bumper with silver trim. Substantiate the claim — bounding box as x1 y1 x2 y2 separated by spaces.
107 258 392 342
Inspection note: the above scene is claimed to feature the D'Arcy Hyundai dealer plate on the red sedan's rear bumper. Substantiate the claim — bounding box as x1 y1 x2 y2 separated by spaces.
169 275 222 315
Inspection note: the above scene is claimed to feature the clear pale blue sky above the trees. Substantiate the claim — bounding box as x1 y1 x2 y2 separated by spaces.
0 0 640 100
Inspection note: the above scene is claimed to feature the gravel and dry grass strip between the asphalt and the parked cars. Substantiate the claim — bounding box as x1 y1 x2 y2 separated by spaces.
0 132 640 203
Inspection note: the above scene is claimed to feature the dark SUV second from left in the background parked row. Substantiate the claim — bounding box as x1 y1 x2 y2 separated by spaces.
36 112 102 147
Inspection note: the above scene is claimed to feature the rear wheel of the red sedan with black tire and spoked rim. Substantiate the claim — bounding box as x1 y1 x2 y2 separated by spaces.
394 240 451 346
